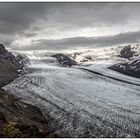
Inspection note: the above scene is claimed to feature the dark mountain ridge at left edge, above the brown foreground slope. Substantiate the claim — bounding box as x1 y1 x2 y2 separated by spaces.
0 44 29 87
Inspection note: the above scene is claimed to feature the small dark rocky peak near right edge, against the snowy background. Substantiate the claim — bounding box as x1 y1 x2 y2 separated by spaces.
118 45 135 59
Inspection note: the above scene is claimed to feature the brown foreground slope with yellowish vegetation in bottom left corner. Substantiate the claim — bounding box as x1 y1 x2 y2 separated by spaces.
0 90 55 138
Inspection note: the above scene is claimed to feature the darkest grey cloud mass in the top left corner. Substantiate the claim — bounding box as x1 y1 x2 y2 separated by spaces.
0 3 49 34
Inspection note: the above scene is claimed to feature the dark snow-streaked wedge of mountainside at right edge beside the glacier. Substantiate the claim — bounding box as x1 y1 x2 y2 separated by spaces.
109 59 140 78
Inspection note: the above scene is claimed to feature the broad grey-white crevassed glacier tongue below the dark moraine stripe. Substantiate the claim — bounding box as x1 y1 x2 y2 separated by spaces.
4 50 140 137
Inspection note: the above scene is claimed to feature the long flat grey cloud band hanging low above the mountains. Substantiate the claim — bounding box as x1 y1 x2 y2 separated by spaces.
16 31 140 50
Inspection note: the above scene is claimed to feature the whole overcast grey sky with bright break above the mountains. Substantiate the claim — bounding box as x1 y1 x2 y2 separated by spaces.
0 3 140 49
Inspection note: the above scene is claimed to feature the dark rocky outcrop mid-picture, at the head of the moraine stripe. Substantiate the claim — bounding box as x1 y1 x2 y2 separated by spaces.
52 53 77 67
